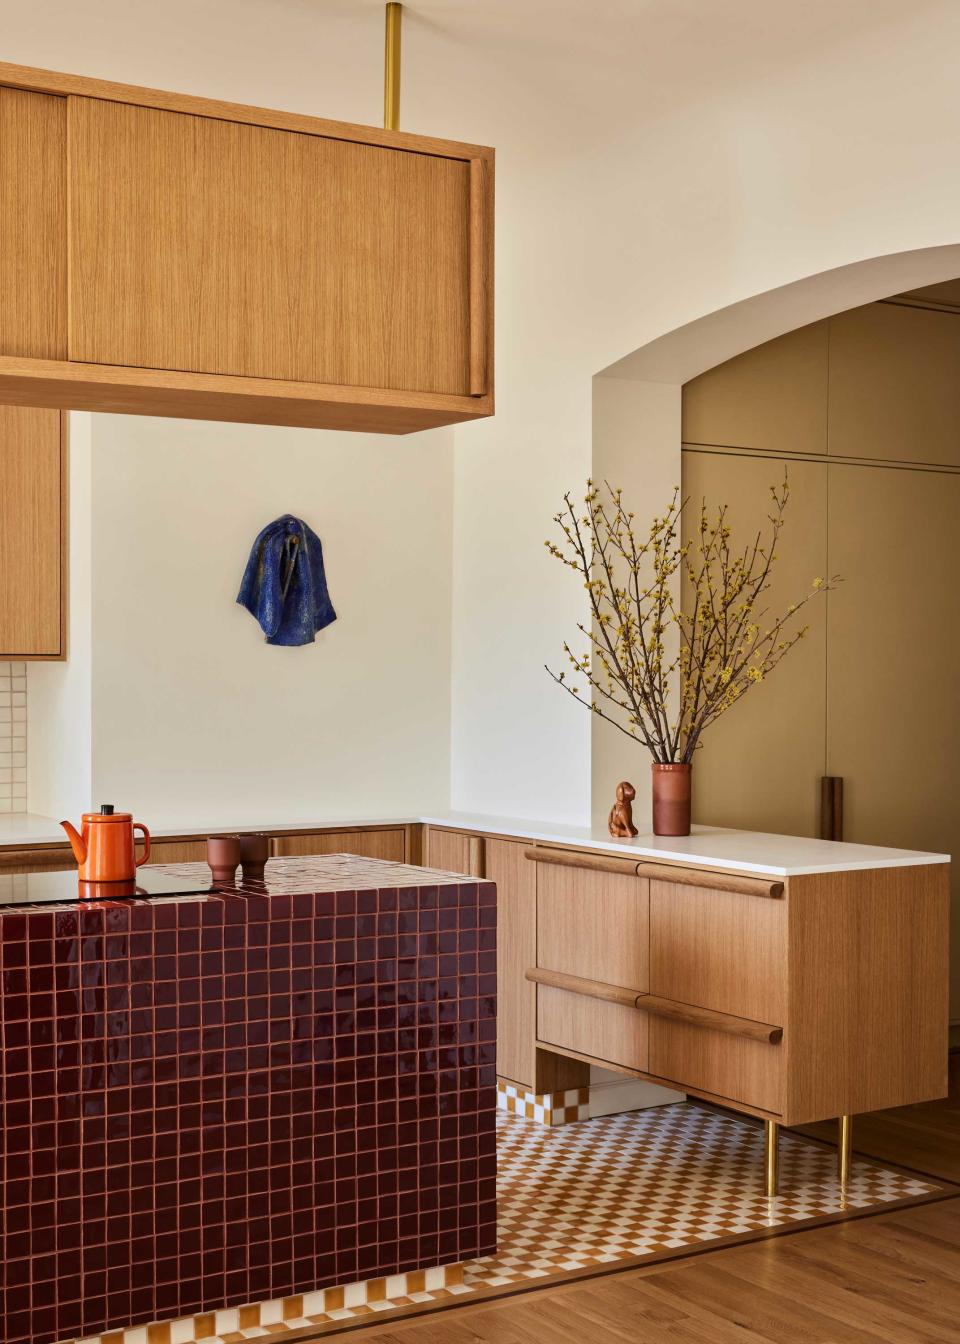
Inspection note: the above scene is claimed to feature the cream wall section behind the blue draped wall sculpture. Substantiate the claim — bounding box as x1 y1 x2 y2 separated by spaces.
83 415 453 825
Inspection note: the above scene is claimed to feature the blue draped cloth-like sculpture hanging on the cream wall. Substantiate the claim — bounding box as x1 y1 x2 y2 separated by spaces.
237 513 336 645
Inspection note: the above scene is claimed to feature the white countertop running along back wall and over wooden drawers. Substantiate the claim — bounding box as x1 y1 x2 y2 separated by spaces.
0 812 951 878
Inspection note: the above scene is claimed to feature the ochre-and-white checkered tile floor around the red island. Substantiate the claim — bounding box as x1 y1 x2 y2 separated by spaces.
63 1102 949 1344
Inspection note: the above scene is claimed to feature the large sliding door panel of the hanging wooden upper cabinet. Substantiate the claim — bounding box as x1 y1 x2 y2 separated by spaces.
69 98 476 395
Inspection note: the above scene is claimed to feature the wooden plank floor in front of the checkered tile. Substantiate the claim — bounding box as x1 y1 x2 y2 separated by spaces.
336 1058 960 1344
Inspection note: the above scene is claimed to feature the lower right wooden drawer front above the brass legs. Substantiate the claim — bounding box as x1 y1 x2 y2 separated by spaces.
648 1016 785 1116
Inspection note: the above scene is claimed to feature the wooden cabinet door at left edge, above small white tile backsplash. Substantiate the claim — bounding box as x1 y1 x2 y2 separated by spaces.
0 406 63 659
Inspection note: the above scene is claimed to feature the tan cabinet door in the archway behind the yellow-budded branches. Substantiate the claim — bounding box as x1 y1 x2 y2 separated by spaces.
682 452 835 836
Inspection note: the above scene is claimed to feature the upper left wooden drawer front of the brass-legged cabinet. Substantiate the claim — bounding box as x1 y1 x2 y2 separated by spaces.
536 863 649 992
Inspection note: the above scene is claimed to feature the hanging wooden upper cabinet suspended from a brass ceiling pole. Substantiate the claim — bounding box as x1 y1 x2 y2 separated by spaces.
0 65 493 433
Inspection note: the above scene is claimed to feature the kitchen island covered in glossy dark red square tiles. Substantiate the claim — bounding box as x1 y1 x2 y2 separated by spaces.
0 855 496 1344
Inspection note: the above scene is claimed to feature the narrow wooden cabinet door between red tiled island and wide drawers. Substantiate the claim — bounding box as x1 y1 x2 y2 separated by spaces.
484 839 536 1090
